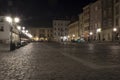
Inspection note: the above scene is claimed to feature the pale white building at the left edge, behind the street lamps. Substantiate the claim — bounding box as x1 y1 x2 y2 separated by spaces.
0 16 20 50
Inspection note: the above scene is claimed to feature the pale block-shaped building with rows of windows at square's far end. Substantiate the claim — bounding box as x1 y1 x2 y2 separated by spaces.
53 20 70 42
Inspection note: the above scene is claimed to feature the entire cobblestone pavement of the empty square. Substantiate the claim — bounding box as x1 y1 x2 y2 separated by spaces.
0 43 120 80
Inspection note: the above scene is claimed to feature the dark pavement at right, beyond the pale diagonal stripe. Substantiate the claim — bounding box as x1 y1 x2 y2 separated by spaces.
61 44 120 66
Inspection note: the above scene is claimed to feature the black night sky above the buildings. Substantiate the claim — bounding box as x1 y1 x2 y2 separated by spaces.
0 0 95 27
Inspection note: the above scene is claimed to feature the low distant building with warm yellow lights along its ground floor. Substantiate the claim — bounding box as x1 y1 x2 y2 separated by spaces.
30 28 53 41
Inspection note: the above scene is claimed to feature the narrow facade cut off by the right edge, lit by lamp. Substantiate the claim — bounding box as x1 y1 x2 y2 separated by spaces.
113 0 120 40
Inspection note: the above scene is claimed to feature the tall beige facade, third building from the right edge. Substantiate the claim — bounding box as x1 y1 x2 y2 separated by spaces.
89 0 102 40
